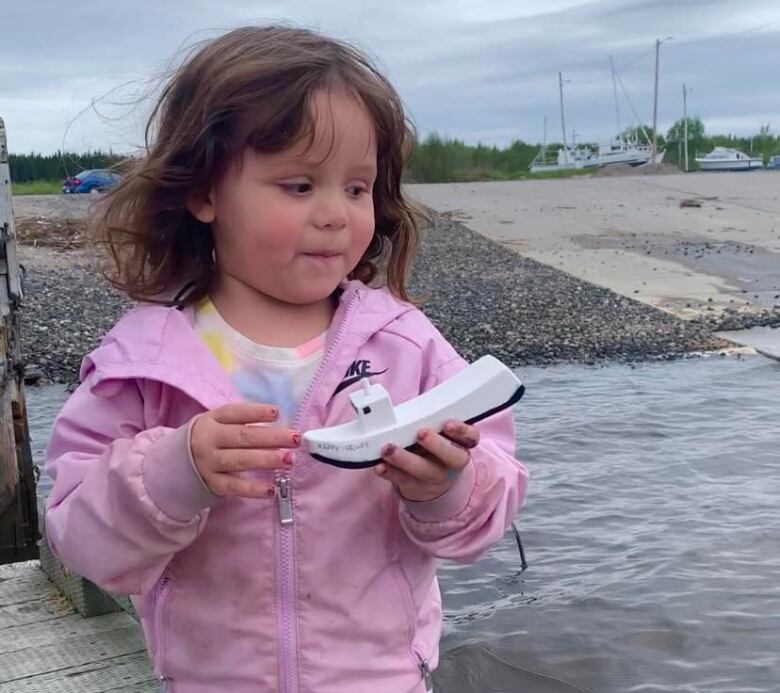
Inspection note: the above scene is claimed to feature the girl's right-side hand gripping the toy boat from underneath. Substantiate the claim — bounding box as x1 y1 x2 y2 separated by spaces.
374 421 479 501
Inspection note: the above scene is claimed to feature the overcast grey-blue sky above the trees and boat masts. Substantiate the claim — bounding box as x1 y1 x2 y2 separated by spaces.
0 0 780 153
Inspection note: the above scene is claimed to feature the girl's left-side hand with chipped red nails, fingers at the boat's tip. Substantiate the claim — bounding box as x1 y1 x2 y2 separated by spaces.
190 402 301 498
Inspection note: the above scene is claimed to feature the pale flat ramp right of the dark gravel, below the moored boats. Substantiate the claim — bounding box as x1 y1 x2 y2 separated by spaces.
409 174 780 329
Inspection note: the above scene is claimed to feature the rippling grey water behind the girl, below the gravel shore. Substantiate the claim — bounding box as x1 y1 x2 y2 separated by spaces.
29 356 780 693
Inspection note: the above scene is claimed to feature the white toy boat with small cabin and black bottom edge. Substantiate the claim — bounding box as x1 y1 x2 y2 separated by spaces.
303 356 525 469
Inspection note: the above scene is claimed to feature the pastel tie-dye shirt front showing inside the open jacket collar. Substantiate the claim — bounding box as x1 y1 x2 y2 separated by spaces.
195 299 325 425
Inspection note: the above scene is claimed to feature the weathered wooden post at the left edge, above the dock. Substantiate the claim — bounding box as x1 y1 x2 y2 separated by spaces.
0 119 40 564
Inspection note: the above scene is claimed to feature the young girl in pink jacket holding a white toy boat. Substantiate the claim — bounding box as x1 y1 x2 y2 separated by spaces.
47 27 526 693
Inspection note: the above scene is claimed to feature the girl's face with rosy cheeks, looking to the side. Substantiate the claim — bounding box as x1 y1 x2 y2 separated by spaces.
190 91 377 305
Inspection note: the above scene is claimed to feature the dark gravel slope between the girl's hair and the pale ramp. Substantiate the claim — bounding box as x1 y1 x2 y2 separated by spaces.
413 217 729 366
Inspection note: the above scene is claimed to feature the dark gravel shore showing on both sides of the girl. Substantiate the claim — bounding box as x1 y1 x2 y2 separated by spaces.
14 196 729 383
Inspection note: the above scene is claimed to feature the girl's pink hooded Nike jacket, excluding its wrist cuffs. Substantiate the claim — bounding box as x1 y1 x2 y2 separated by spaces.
46 282 527 693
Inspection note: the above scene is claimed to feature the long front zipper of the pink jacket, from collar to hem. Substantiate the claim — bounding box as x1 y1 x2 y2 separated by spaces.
274 294 358 693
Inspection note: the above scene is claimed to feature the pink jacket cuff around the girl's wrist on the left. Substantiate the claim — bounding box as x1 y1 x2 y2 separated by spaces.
143 417 220 522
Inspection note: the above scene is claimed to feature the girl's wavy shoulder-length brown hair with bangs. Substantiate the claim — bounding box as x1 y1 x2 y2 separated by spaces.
95 26 419 305
